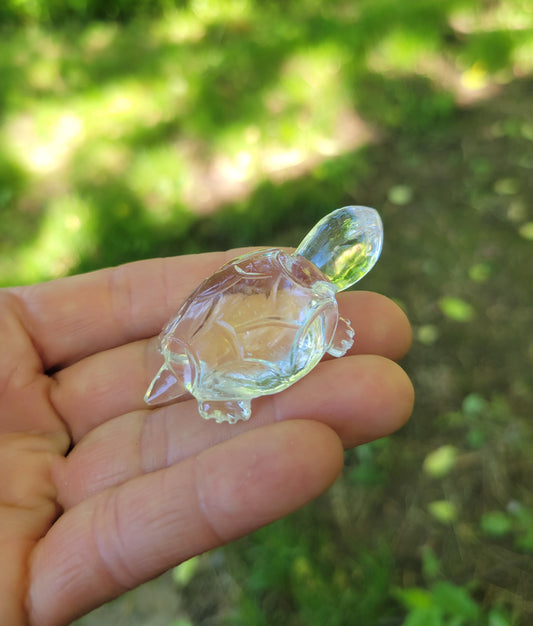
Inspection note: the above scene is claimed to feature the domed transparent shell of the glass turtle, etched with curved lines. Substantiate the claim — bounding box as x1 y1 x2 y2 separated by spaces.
161 249 338 400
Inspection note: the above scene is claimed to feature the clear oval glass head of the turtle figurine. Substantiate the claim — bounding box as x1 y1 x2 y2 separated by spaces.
294 206 383 291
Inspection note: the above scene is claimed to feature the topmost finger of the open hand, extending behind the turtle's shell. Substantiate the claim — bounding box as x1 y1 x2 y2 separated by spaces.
10 249 249 369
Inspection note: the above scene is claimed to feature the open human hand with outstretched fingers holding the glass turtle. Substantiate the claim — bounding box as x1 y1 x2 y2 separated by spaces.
0 250 413 626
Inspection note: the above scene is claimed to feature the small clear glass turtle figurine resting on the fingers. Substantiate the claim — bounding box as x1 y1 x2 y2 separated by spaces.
145 206 383 424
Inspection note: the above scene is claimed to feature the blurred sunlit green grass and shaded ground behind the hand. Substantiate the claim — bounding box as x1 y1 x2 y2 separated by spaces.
0 0 533 626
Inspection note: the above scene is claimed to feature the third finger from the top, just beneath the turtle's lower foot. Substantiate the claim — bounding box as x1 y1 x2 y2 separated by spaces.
56 355 413 508
